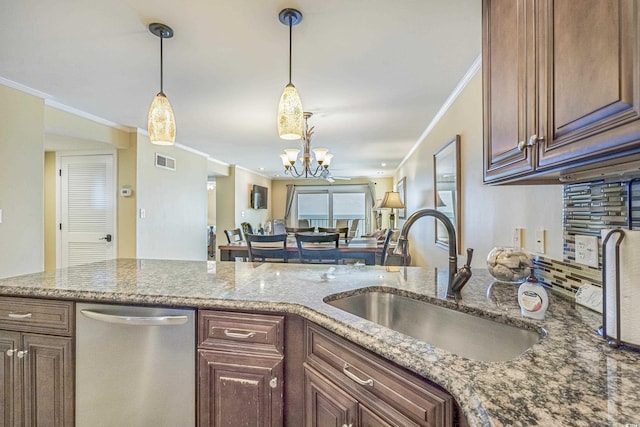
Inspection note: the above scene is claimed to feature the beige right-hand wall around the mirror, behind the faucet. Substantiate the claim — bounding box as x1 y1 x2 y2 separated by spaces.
395 71 563 267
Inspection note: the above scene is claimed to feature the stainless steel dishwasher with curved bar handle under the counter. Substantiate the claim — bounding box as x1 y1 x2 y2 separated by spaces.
76 303 196 427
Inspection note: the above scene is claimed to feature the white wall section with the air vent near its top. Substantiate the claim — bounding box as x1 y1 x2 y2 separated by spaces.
136 134 208 260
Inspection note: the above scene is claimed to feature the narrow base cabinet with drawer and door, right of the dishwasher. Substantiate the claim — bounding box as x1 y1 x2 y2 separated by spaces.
198 310 284 427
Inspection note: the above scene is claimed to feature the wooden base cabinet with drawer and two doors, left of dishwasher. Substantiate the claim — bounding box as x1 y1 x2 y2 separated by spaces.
0 298 74 426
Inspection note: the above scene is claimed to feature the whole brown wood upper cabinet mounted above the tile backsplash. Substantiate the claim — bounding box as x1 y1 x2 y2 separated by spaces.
482 0 640 183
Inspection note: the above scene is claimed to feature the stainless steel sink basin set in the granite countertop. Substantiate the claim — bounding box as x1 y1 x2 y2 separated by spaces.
325 291 541 362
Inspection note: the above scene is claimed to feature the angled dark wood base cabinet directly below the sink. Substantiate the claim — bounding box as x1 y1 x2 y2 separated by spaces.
305 323 464 427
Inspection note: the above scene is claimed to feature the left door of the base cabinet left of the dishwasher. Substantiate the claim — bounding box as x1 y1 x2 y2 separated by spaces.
0 331 21 427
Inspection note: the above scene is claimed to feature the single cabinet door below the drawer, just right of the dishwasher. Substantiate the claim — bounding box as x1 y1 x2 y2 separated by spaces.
198 350 283 427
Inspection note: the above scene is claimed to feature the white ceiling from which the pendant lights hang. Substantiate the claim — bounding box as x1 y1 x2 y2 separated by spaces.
0 0 481 177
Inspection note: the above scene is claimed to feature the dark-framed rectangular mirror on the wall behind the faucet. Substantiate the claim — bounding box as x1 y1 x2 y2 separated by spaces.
433 135 461 253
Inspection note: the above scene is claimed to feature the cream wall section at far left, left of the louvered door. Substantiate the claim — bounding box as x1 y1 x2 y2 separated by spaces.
0 85 44 277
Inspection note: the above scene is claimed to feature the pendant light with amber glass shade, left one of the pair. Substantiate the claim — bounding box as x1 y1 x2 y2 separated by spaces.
147 23 176 145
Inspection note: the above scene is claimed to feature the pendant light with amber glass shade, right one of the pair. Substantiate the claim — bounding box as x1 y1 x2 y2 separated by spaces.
278 9 303 140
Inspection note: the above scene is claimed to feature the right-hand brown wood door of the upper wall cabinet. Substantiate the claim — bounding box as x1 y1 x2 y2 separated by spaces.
538 0 640 170
